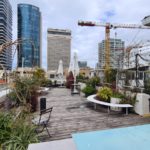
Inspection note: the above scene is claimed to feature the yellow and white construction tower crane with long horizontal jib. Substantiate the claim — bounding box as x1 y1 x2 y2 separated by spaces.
78 21 150 70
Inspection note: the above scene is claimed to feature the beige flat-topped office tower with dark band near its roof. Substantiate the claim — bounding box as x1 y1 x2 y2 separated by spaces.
47 29 71 70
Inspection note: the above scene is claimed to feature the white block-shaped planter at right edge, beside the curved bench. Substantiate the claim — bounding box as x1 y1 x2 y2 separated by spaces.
134 93 150 115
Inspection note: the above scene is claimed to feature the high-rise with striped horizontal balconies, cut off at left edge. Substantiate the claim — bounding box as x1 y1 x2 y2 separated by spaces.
0 0 12 70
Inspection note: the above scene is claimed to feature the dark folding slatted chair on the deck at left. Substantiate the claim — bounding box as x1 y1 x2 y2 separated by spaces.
32 107 53 137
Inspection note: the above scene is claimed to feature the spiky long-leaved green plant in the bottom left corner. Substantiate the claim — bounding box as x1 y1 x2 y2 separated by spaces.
0 112 38 150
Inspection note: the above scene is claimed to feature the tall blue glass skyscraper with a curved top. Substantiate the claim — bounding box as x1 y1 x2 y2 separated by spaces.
18 4 41 68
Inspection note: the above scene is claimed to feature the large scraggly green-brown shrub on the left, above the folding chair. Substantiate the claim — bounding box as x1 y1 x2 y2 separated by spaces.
8 77 40 111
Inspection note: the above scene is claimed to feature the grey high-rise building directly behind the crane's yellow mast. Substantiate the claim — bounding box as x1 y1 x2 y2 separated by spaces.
98 38 124 69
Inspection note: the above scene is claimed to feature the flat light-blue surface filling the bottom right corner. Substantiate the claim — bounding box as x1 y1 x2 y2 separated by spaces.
72 124 150 150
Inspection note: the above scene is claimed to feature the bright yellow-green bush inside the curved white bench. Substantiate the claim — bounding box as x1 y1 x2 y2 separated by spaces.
97 87 112 102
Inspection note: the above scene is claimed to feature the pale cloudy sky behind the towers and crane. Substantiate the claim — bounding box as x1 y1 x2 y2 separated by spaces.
9 0 150 69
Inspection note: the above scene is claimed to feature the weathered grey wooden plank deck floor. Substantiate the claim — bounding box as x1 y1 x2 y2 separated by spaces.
39 88 150 141
